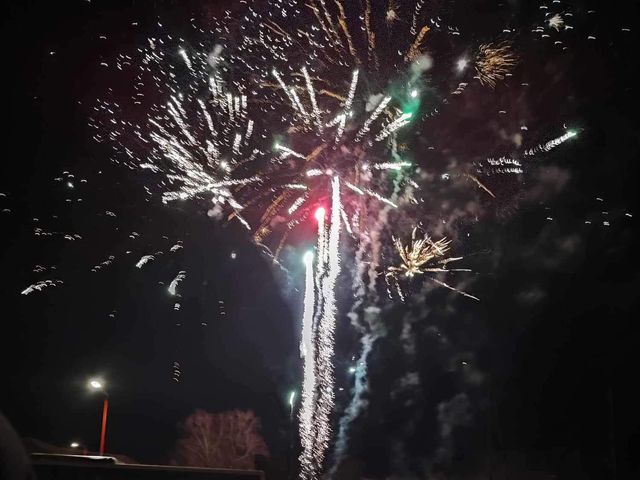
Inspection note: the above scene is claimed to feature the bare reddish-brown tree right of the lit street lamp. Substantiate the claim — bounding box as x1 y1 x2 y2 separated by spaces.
171 410 269 469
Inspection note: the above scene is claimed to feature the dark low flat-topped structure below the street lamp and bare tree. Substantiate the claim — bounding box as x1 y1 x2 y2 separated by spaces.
31 454 264 480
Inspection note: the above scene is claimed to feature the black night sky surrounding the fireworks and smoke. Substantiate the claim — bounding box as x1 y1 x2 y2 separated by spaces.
0 0 640 478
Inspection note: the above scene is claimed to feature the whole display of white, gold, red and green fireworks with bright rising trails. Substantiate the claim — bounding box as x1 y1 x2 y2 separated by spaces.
87 0 588 478
